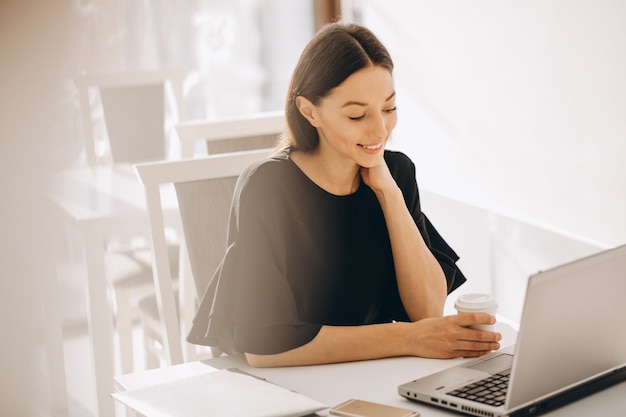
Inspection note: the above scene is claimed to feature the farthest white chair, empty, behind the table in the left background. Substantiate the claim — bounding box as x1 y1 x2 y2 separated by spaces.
75 71 186 373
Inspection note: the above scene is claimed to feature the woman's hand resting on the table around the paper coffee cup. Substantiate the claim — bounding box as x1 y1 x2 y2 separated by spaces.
406 313 502 359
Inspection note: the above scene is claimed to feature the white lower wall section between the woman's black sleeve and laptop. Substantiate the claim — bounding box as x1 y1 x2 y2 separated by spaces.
421 190 603 323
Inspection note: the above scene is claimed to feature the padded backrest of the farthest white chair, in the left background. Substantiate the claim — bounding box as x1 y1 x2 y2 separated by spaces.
75 71 185 168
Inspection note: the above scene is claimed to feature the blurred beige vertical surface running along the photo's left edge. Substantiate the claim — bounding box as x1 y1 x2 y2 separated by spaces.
0 0 69 416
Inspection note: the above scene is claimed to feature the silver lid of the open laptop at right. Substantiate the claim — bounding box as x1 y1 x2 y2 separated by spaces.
506 245 626 409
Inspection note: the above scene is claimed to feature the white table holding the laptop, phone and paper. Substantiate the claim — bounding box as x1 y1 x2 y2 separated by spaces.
115 324 626 417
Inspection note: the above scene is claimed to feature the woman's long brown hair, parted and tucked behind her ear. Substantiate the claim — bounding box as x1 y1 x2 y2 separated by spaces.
278 23 393 152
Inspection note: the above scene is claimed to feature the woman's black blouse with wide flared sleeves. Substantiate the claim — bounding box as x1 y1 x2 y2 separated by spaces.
188 151 465 354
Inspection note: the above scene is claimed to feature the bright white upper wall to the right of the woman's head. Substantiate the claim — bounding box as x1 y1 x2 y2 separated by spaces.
360 0 626 246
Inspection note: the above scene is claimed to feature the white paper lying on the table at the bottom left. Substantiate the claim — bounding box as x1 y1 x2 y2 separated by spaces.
113 370 327 417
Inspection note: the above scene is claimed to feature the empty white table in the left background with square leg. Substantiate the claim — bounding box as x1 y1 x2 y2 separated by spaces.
49 164 178 417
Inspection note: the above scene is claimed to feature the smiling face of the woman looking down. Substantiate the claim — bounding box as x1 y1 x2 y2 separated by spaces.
302 66 397 168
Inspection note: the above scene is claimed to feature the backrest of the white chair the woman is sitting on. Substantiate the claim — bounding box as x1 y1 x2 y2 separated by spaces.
135 149 272 365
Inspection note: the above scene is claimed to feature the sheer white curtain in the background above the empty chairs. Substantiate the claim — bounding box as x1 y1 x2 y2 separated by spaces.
69 0 313 118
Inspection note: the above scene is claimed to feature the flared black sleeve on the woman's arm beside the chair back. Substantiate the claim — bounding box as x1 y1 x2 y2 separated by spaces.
188 159 321 354
